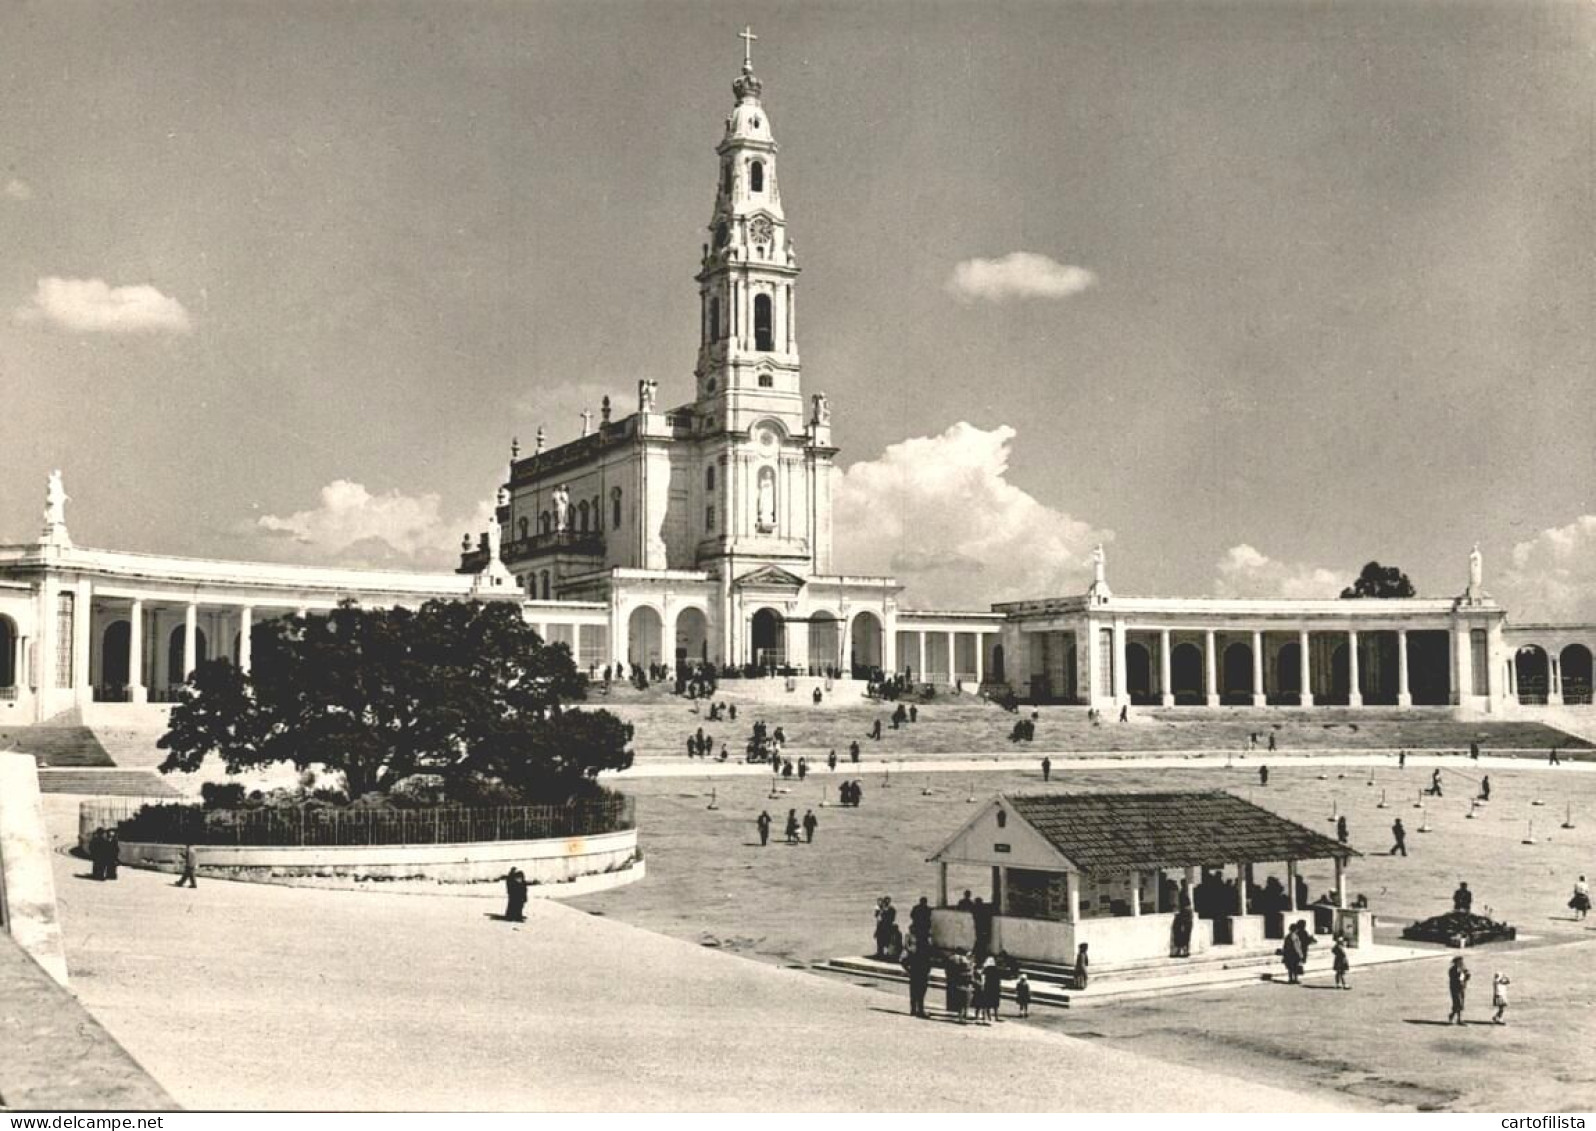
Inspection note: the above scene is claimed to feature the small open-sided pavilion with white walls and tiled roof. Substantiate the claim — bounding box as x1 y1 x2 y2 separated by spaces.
930 791 1374 965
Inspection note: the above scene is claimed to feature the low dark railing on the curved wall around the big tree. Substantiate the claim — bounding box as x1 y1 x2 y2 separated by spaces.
91 796 637 847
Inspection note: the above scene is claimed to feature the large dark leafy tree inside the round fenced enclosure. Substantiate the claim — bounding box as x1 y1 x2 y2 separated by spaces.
160 601 632 799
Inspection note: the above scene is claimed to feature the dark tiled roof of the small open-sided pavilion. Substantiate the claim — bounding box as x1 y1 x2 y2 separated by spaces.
1004 791 1358 873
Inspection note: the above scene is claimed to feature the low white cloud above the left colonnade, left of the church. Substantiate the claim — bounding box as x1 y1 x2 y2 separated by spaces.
251 479 493 569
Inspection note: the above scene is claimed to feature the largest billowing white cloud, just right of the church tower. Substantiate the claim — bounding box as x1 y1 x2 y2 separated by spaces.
833 423 1112 609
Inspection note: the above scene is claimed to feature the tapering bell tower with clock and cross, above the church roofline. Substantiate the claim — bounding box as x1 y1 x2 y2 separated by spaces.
694 29 806 435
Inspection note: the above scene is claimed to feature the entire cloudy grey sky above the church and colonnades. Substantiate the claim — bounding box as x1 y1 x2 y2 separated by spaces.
0 0 1596 621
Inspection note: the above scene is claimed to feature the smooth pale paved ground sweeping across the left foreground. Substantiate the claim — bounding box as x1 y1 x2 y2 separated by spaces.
43 806 1340 1110
